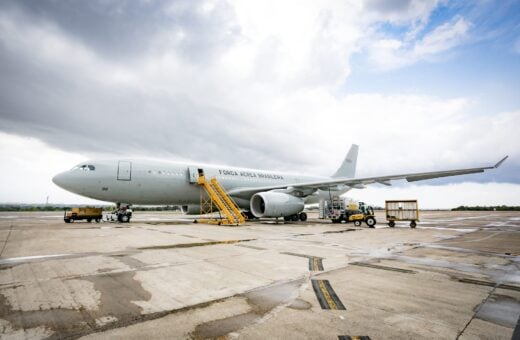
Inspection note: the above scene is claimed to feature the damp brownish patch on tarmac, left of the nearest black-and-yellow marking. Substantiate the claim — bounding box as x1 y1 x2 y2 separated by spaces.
191 279 304 339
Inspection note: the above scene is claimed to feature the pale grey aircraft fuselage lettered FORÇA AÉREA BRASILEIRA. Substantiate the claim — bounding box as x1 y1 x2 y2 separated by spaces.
53 159 327 209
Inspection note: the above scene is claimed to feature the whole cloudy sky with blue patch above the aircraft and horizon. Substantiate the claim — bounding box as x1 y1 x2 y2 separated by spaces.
0 0 520 208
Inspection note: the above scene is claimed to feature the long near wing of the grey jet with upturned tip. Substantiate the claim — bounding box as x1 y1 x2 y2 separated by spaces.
228 156 508 198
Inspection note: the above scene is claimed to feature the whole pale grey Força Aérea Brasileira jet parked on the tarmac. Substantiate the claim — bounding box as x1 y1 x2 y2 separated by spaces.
52 144 507 221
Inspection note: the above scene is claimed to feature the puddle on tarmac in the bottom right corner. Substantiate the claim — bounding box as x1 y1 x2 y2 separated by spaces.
476 295 520 328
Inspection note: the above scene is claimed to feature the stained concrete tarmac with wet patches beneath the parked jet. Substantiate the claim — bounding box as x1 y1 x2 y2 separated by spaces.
0 211 520 339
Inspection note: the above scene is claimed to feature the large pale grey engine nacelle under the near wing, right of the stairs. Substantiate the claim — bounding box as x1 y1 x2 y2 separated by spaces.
250 191 304 217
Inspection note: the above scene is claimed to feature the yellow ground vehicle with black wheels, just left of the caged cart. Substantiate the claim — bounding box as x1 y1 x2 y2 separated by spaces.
319 197 376 228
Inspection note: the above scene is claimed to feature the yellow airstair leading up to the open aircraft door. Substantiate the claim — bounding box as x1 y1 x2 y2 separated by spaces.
197 175 246 225
